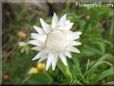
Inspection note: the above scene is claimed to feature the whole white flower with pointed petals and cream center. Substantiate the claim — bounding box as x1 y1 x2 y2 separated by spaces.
29 13 81 70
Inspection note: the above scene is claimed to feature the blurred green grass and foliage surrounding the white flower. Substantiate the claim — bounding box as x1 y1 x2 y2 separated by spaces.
2 0 114 84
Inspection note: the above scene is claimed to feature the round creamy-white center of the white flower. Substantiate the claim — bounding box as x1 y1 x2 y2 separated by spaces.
46 29 67 53
